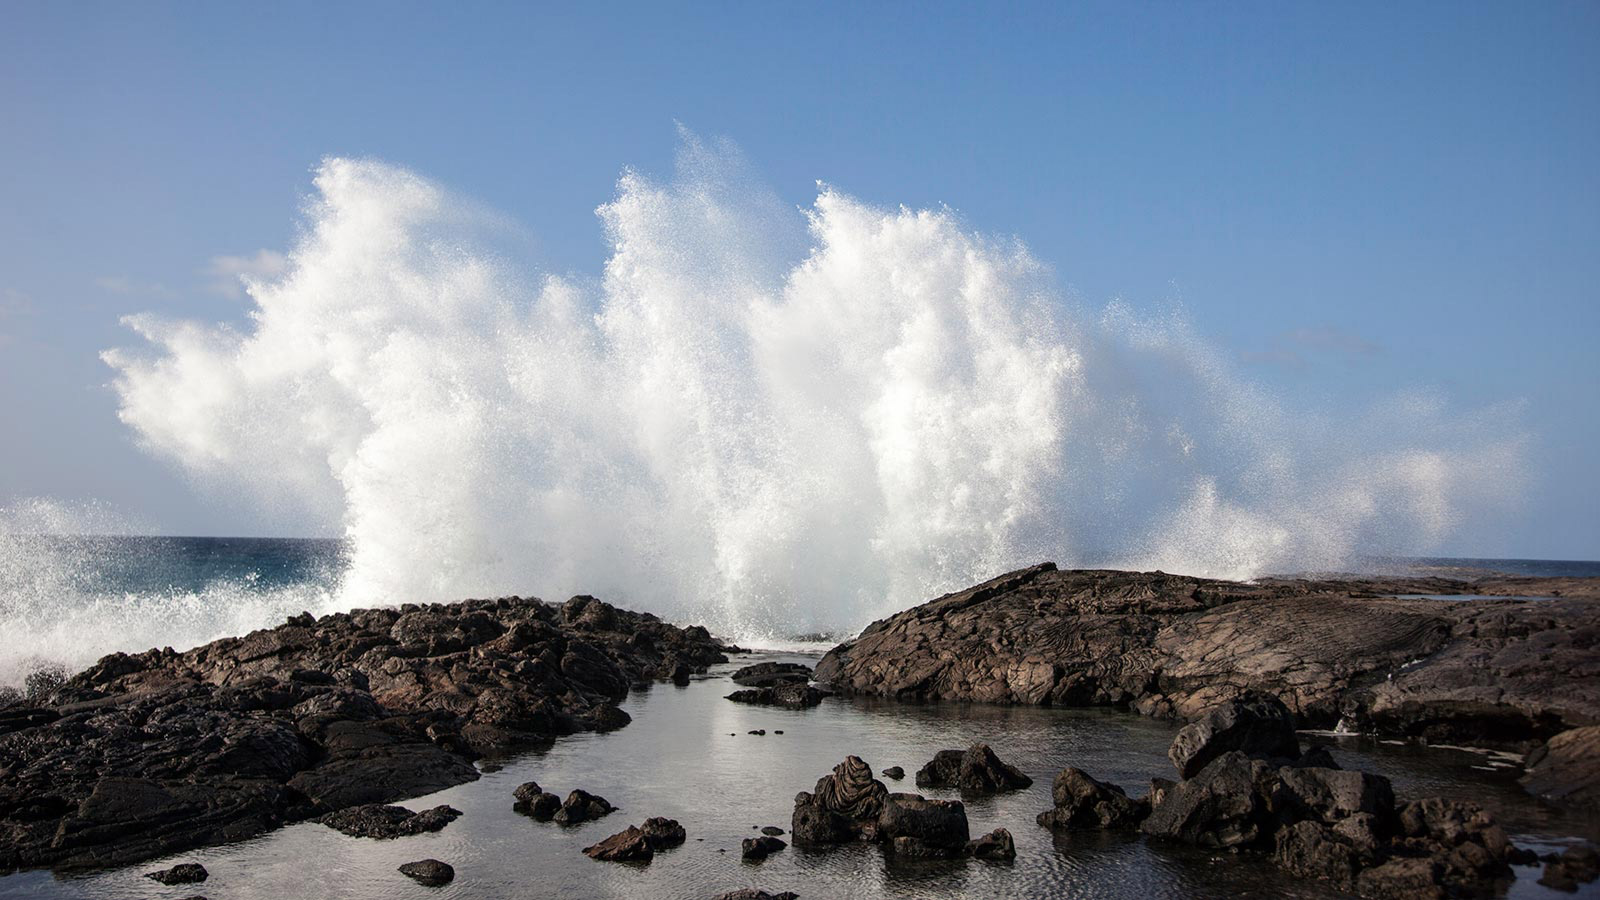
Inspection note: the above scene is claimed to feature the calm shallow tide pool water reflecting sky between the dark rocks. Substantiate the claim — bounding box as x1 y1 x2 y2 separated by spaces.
0 655 1600 900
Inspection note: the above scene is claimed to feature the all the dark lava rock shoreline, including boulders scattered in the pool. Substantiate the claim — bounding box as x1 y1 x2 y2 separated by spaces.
0 564 1600 895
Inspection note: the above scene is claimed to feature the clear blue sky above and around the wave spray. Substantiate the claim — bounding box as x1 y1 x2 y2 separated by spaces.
0 0 1600 559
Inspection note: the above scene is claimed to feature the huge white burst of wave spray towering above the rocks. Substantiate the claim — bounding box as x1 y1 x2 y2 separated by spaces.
78 138 1522 637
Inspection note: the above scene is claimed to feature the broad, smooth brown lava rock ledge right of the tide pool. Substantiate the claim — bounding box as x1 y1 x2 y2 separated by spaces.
814 564 1600 801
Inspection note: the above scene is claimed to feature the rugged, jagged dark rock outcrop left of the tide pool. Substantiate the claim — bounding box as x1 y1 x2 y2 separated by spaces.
0 597 736 871
